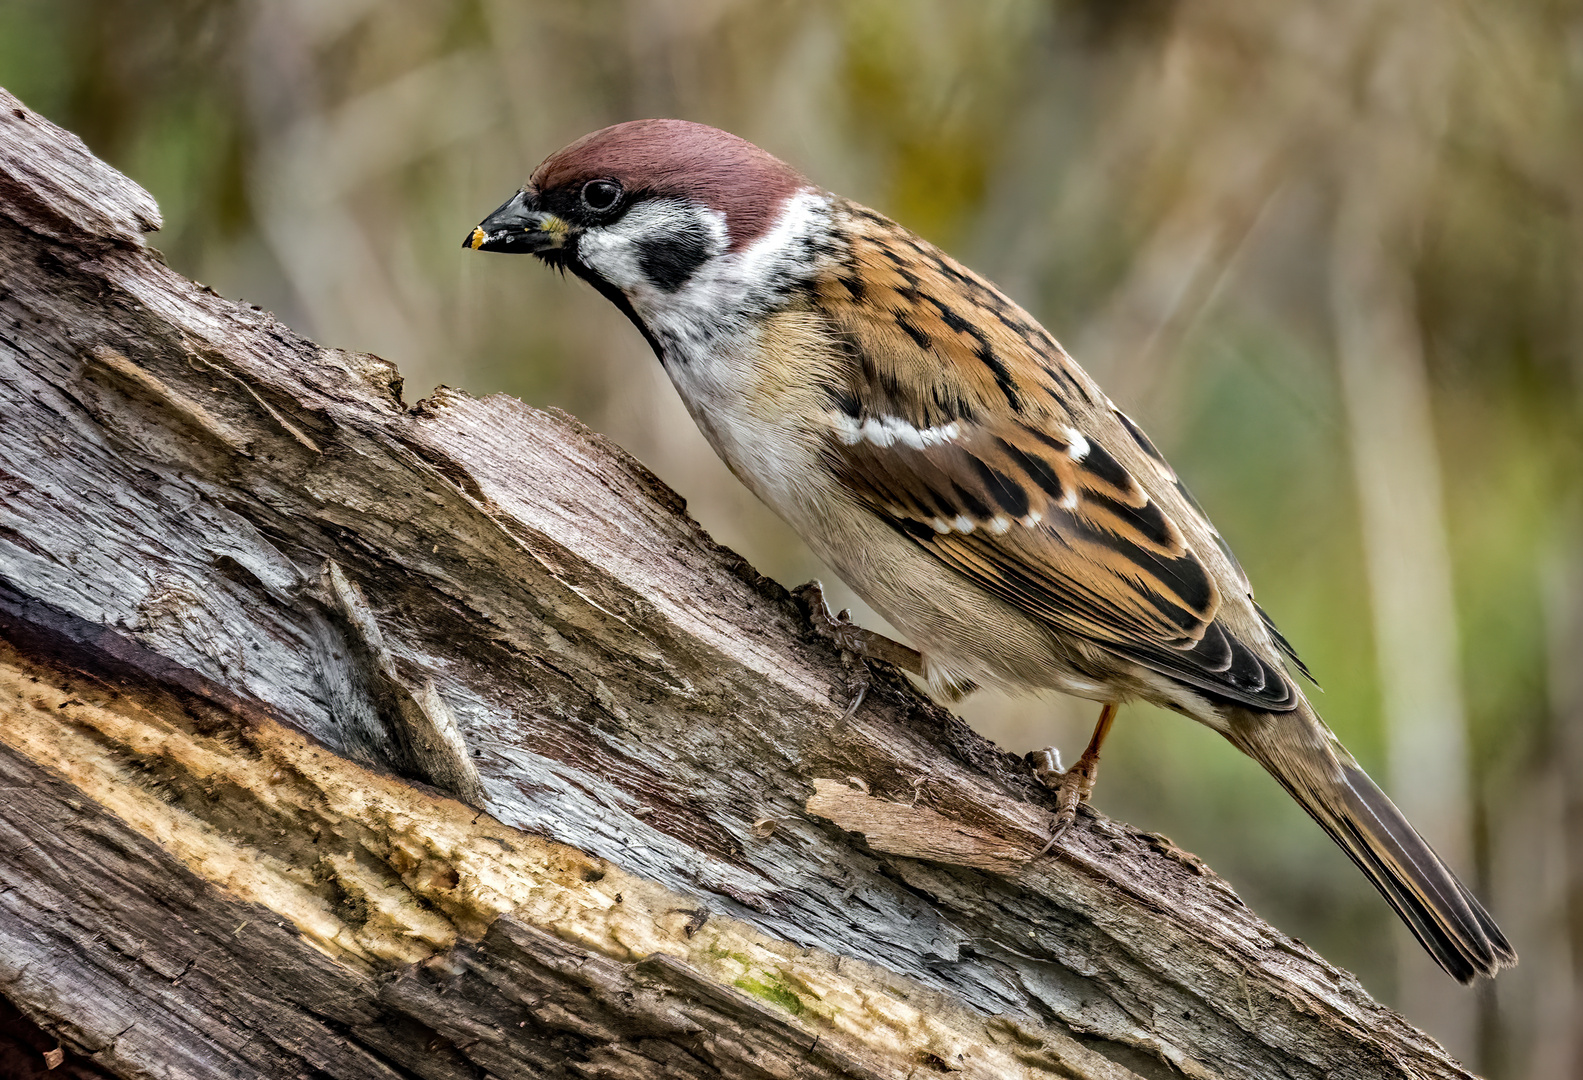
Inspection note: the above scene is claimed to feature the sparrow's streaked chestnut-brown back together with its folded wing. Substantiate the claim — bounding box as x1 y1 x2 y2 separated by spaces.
815 207 1298 711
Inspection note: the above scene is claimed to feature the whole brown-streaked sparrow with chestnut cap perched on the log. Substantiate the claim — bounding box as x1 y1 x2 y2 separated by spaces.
464 120 1517 983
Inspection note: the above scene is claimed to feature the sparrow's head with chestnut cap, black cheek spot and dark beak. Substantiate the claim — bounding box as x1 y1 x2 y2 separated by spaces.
464 120 807 299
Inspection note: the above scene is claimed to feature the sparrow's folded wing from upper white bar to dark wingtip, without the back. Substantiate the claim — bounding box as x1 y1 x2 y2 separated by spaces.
833 414 1296 711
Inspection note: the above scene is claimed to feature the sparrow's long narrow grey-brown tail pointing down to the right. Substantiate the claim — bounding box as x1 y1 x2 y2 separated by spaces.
1228 702 1517 983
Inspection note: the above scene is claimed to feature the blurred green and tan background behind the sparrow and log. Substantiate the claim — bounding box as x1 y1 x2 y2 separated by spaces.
0 0 1583 1078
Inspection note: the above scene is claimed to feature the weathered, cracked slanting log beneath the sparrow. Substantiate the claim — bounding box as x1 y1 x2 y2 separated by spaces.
0 92 1466 1078
